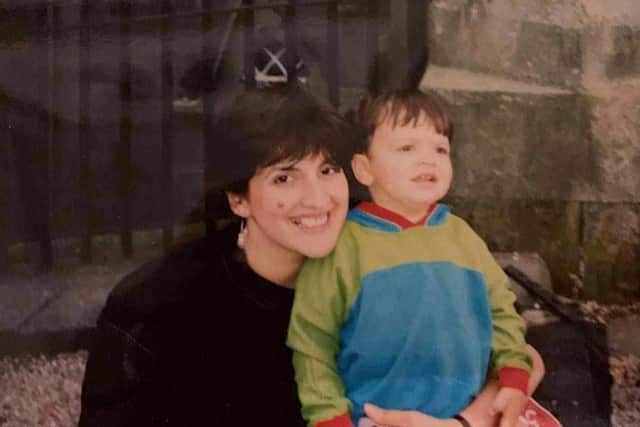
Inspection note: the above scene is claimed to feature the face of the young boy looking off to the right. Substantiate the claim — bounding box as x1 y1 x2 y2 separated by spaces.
352 112 453 221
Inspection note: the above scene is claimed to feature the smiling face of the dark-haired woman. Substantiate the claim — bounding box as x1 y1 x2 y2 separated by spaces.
232 155 349 262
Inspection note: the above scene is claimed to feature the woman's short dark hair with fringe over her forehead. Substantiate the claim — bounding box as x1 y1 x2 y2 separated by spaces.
207 84 356 216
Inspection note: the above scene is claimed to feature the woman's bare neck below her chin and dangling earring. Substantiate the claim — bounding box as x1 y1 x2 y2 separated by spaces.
244 220 304 289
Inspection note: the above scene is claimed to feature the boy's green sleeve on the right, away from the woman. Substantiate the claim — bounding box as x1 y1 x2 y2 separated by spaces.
481 242 532 373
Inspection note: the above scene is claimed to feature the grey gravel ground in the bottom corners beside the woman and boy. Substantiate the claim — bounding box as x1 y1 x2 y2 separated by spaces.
0 351 640 427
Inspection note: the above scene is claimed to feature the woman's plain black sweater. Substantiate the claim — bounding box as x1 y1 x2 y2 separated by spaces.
79 227 304 427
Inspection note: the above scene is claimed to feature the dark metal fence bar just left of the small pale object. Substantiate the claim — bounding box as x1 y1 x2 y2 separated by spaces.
160 0 174 252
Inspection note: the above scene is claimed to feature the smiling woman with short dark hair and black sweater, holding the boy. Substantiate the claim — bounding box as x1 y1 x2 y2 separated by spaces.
79 87 540 427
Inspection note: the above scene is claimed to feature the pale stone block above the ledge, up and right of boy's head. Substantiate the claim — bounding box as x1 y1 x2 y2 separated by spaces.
428 0 585 88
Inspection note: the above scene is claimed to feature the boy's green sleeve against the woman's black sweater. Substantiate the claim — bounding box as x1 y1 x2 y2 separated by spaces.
287 232 358 426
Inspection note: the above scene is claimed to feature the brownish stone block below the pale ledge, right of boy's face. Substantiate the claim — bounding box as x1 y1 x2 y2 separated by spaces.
436 90 599 200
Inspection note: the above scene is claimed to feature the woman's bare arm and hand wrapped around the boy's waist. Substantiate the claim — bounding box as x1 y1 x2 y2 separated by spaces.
365 345 545 427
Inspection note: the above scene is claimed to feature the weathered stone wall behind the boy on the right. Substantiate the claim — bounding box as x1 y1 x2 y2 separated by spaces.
422 0 640 302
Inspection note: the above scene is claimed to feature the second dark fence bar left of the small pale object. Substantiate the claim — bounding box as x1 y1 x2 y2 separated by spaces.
116 0 133 258
